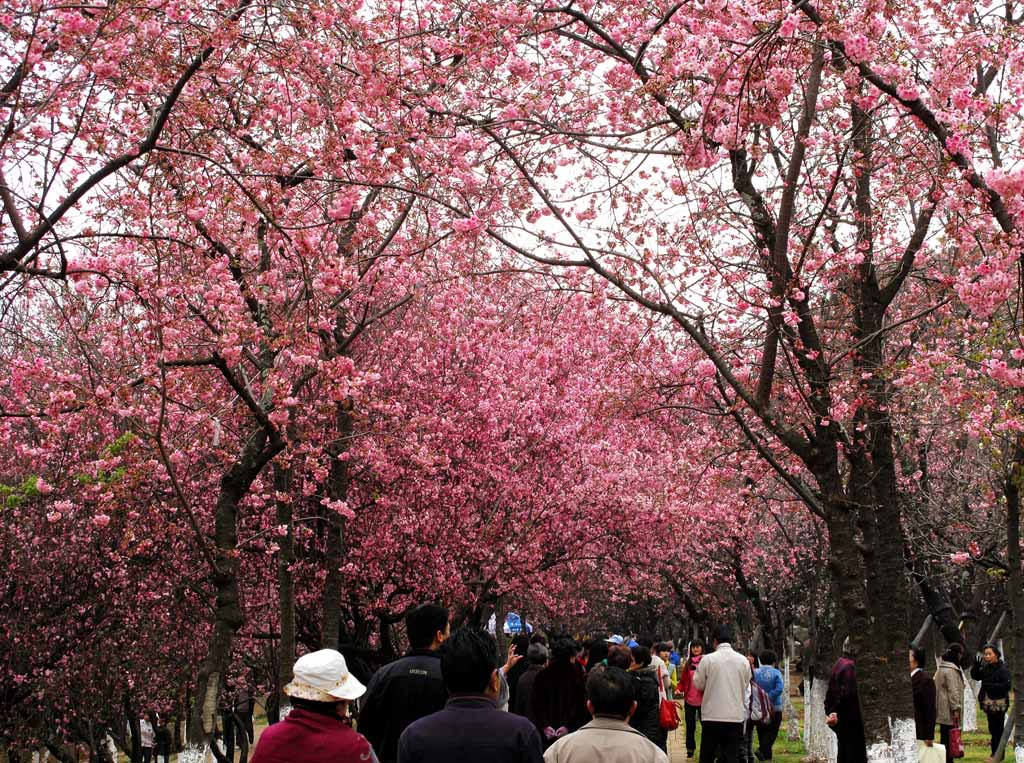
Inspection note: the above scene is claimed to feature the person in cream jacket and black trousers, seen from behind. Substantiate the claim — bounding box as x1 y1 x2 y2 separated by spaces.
693 625 751 763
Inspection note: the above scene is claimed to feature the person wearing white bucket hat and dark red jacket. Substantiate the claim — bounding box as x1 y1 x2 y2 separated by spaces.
252 649 377 763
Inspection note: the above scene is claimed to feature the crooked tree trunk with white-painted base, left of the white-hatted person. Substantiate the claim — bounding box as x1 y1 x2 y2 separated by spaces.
178 427 285 763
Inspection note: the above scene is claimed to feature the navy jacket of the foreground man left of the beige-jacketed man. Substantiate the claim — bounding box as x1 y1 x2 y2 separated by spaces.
398 695 544 763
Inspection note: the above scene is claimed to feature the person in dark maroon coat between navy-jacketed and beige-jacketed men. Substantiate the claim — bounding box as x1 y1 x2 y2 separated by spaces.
528 637 589 748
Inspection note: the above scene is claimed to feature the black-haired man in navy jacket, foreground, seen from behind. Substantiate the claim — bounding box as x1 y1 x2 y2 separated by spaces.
398 628 544 763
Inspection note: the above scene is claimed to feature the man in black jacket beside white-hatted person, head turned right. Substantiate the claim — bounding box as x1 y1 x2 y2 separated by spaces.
358 604 451 763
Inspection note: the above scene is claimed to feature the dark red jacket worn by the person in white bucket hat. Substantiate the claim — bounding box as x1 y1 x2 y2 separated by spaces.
252 708 374 763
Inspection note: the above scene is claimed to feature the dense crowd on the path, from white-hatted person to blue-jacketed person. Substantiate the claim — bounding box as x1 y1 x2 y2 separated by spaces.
252 604 784 763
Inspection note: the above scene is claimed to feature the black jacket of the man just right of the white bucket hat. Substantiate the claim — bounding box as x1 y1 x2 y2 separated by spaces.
357 649 447 763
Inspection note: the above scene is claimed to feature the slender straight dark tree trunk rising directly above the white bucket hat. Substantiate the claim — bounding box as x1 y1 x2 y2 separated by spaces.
321 400 352 649
